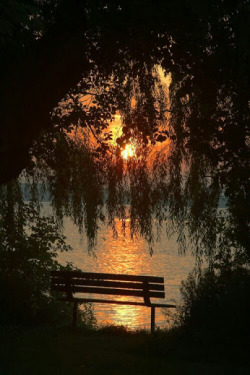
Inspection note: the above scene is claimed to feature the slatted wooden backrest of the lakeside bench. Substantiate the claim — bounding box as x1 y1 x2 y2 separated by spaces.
51 271 165 305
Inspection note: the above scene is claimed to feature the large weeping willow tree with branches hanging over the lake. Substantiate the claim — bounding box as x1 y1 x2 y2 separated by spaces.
1 0 250 262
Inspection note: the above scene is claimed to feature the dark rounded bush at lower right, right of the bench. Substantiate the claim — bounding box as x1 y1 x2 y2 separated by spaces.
178 258 250 343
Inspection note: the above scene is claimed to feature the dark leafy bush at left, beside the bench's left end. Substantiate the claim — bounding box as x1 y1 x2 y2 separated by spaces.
0 181 94 325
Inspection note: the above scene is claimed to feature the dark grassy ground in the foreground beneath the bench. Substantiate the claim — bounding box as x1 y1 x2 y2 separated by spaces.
0 327 250 375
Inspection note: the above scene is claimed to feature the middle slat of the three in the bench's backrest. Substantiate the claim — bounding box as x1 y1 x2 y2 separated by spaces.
51 277 164 291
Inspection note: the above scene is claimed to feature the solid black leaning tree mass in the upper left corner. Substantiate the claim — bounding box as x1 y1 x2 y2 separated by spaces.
0 0 88 182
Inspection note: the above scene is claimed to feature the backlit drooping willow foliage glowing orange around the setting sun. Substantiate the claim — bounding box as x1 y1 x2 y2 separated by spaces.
23 58 248 259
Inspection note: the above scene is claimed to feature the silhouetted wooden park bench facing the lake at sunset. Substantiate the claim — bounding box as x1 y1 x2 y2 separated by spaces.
51 271 176 332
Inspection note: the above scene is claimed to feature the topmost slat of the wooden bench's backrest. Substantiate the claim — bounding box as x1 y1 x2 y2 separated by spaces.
51 271 164 283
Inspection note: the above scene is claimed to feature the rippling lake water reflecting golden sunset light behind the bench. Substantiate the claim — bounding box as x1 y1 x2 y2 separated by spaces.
58 212 194 329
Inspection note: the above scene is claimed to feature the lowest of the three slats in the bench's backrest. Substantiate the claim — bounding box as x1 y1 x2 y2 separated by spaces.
51 285 165 298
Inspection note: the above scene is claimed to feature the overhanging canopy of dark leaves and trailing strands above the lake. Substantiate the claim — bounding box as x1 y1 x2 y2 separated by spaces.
0 0 250 259
